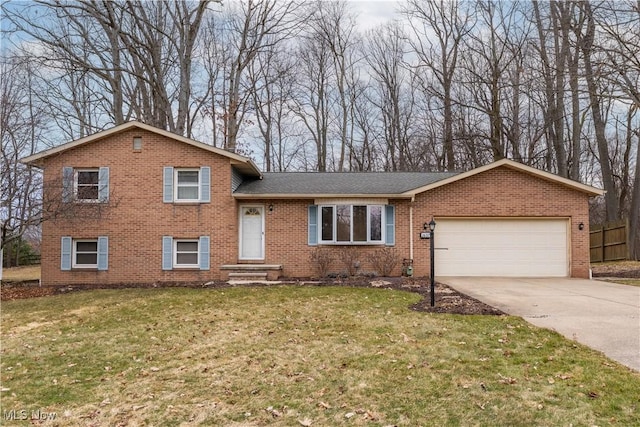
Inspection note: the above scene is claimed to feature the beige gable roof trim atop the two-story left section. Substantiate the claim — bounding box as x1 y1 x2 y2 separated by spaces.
21 121 262 177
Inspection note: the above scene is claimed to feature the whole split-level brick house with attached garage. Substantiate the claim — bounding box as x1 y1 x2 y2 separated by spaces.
23 122 603 285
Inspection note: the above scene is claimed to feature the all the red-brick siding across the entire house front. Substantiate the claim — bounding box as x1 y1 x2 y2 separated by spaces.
42 130 589 285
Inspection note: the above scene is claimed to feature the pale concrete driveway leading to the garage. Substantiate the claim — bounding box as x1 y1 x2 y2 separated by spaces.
437 277 640 371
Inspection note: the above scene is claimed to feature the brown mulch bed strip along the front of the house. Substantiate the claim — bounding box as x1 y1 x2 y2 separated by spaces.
0 277 504 315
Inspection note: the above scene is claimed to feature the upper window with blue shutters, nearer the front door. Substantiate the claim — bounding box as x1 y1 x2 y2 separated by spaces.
162 166 211 203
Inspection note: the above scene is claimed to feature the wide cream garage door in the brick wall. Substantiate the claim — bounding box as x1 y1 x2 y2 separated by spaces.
435 218 569 277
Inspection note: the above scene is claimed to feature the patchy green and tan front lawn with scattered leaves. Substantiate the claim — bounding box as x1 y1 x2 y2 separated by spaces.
0 286 640 426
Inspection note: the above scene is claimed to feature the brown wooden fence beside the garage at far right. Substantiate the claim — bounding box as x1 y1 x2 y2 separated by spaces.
589 219 629 262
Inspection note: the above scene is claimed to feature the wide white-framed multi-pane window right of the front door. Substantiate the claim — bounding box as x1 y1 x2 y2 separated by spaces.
319 205 384 244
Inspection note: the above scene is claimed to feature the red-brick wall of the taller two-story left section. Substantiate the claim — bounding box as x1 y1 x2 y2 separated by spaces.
42 130 238 285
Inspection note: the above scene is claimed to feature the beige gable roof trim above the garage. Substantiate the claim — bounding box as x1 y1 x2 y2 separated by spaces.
403 159 605 196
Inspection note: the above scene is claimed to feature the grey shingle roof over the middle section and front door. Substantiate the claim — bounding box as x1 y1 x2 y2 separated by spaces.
234 172 458 196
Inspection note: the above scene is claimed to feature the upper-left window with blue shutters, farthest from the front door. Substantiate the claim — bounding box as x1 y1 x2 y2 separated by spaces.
62 166 109 203
